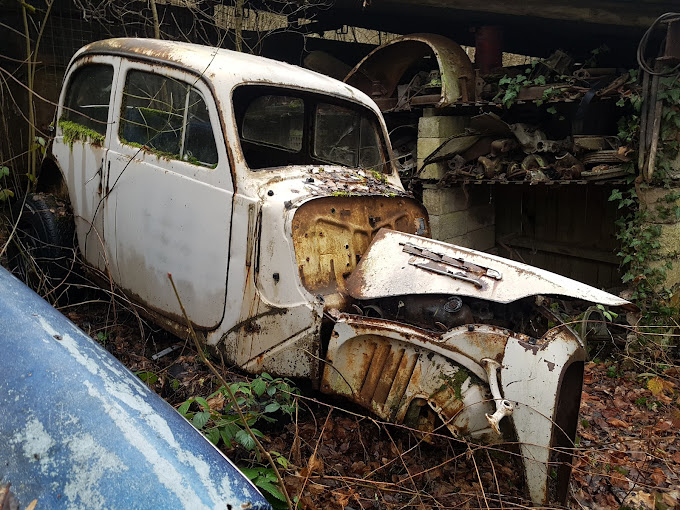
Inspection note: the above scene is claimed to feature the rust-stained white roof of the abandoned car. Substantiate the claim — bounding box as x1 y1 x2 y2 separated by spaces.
71 38 377 107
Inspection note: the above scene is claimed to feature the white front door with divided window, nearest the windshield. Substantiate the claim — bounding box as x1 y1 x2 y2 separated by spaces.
105 62 233 329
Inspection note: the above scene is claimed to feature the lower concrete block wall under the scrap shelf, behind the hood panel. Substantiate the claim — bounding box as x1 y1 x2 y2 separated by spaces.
423 184 496 251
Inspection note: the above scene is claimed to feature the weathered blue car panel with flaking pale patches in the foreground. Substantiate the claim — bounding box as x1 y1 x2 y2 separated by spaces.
0 268 270 510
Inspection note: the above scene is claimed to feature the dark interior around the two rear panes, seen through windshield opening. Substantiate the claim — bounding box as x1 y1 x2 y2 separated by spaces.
231 83 394 175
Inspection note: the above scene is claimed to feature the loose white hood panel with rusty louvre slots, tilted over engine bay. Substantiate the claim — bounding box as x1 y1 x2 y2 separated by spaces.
347 229 635 309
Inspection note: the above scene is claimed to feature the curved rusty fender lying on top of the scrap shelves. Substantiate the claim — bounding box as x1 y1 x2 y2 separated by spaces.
345 34 475 107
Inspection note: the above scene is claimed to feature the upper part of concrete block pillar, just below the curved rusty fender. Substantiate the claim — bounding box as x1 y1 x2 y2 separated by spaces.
416 113 467 180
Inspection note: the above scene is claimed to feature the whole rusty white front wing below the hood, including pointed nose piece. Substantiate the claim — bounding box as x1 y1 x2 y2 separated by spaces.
321 314 586 504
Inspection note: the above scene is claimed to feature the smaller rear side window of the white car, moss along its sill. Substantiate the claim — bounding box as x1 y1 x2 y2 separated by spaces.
60 64 113 135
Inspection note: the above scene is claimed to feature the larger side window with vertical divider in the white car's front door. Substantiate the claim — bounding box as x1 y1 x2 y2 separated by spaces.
119 71 217 166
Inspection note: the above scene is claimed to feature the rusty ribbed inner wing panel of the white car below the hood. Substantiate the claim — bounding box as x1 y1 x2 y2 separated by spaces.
321 316 497 442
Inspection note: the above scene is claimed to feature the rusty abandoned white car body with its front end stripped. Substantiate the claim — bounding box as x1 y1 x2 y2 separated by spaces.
19 39 629 503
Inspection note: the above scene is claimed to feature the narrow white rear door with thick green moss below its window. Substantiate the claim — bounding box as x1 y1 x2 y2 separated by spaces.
52 56 119 271
